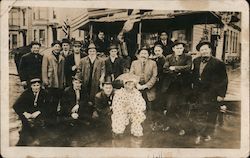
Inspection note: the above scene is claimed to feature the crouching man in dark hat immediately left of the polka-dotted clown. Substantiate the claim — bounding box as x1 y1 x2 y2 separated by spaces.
93 78 114 131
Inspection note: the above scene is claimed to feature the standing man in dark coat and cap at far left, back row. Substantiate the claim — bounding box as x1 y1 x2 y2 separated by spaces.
19 41 43 87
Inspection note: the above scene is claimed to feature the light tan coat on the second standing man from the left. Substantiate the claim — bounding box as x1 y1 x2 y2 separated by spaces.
42 52 65 88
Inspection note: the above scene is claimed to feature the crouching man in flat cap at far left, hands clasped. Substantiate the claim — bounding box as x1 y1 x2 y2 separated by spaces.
13 78 49 145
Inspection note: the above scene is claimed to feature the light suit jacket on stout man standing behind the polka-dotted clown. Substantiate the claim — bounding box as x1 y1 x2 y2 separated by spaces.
130 59 157 101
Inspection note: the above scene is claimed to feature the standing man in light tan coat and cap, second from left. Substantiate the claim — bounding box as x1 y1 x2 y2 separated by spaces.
42 41 65 121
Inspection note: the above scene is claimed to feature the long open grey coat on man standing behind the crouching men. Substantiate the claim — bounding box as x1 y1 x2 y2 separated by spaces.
79 56 105 101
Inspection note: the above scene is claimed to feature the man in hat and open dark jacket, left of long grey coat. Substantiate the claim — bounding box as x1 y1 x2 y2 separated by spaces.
64 41 87 87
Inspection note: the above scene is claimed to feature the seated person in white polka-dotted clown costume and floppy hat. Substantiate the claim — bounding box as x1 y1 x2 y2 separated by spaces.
111 73 146 137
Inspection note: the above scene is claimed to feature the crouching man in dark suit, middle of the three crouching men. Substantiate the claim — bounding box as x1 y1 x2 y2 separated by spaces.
61 75 88 125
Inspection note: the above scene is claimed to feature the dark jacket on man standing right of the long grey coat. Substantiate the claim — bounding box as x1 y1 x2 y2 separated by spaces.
105 57 124 79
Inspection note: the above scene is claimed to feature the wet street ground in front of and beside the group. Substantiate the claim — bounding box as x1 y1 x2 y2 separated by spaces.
9 60 241 149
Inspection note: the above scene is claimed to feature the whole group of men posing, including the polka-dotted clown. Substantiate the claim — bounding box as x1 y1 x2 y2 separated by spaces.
14 31 228 144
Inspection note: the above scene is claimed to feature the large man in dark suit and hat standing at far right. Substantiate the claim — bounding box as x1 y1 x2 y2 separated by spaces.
190 40 228 144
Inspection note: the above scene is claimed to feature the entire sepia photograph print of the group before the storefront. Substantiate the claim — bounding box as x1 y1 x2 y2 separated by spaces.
1 2 249 157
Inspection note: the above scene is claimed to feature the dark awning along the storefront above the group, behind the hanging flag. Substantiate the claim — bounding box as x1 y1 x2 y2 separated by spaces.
78 11 223 34
